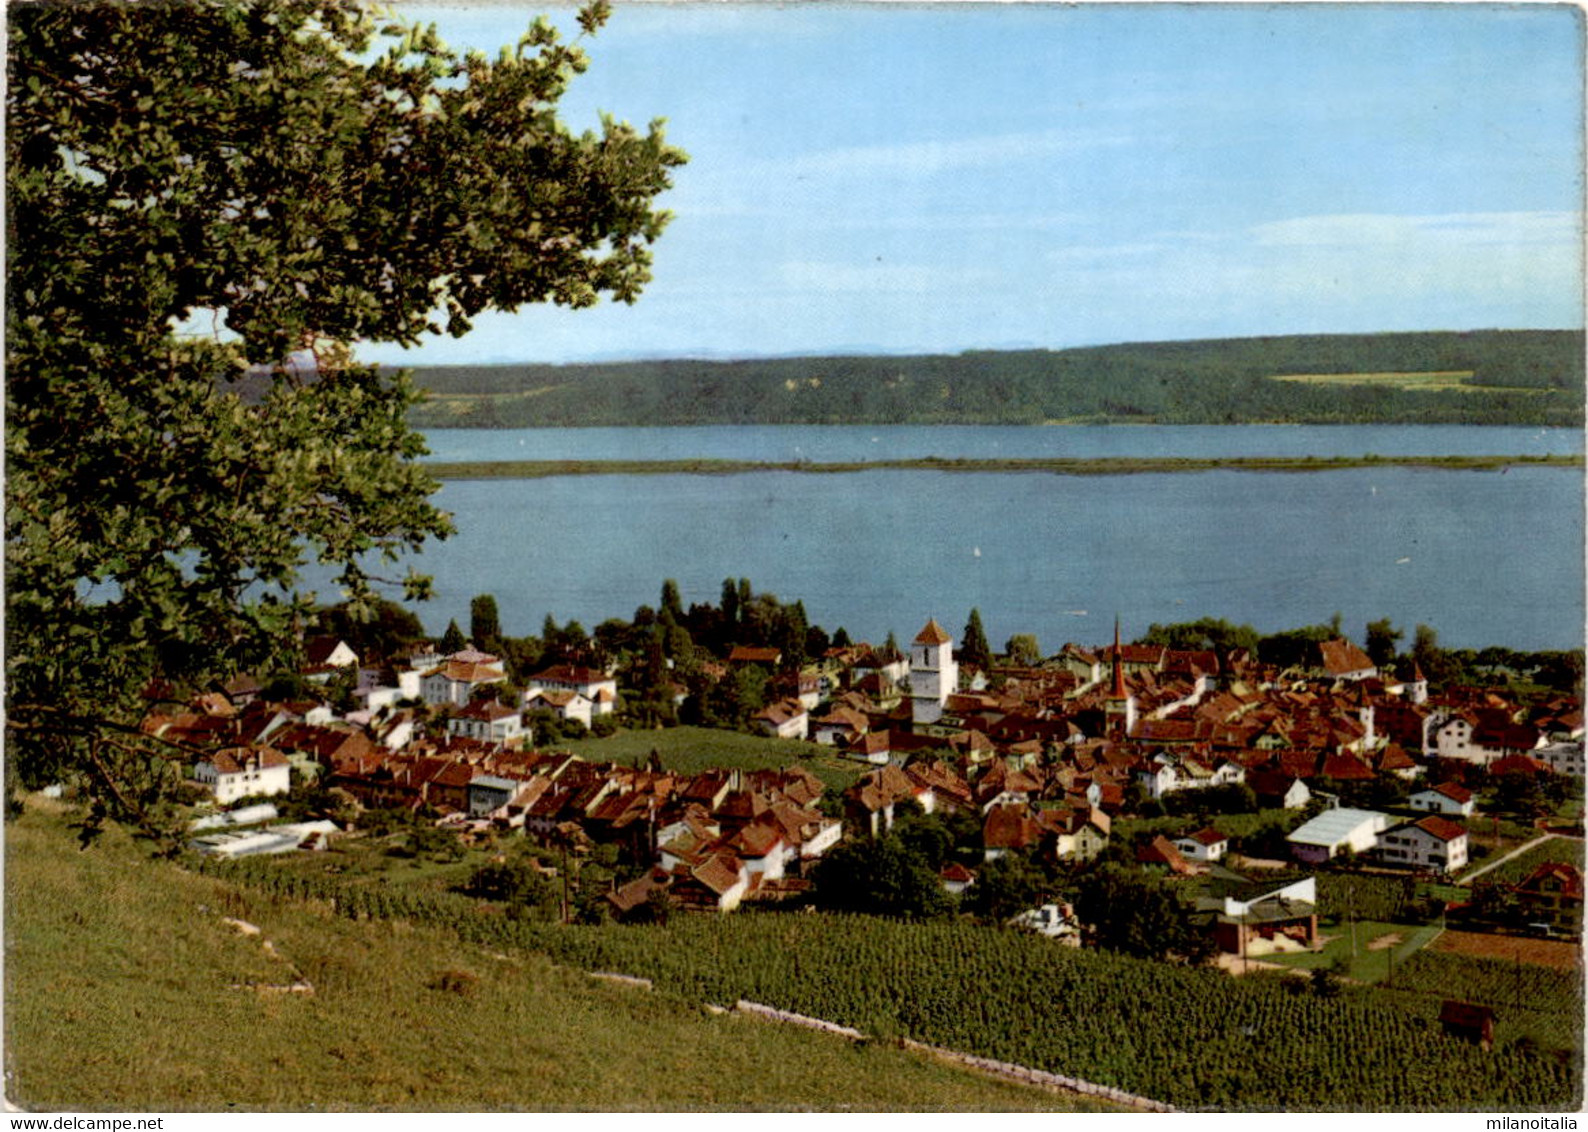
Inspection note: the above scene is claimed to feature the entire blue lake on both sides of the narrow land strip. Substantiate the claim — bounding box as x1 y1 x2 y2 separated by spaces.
344 427 1583 649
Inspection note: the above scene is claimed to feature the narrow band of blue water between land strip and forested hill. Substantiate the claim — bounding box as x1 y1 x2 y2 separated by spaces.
416 424 1583 462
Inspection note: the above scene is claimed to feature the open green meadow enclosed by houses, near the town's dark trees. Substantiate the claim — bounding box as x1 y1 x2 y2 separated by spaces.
559 727 867 791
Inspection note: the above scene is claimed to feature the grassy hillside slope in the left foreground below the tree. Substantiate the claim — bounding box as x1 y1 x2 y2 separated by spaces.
5 807 1092 1111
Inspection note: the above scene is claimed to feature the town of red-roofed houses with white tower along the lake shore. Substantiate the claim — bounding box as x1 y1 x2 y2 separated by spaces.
145 579 1583 977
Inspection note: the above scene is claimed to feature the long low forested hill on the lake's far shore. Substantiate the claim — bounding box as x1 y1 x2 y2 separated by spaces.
403 330 1583 429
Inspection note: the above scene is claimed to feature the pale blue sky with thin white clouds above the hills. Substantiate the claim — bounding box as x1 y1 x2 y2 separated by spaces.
360 2 1583 364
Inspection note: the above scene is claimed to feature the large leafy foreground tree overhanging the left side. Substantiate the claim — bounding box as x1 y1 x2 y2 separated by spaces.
5 0 683 832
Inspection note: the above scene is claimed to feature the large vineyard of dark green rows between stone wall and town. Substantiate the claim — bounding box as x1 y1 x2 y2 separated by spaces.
200 861 1582 1111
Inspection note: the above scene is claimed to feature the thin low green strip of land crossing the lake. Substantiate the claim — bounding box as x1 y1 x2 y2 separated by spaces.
422 454 1583 479
